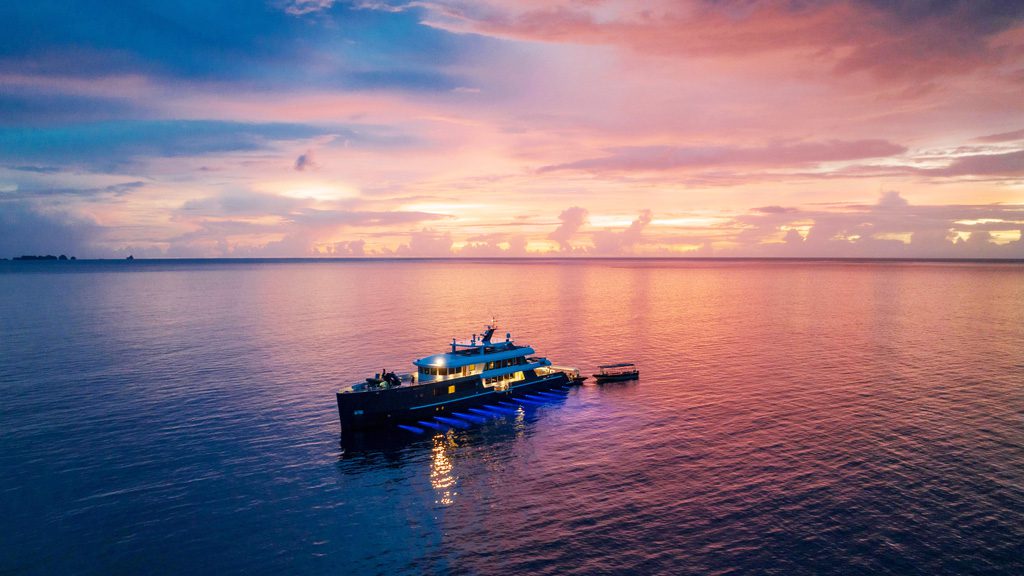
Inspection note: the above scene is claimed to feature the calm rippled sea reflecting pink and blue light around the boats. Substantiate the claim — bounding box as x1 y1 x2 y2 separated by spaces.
0 260 1024 574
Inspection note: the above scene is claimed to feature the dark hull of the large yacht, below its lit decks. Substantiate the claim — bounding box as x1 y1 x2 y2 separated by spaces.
337 370 570 431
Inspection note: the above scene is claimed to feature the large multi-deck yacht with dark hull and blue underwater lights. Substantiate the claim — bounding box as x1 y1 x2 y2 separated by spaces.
337 323 585 433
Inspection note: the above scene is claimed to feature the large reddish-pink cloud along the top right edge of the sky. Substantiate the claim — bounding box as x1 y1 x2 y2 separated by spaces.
399 0 1021 78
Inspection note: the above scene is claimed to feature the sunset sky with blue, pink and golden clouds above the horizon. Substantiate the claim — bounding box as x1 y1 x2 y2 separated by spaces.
0 0 1024 257
